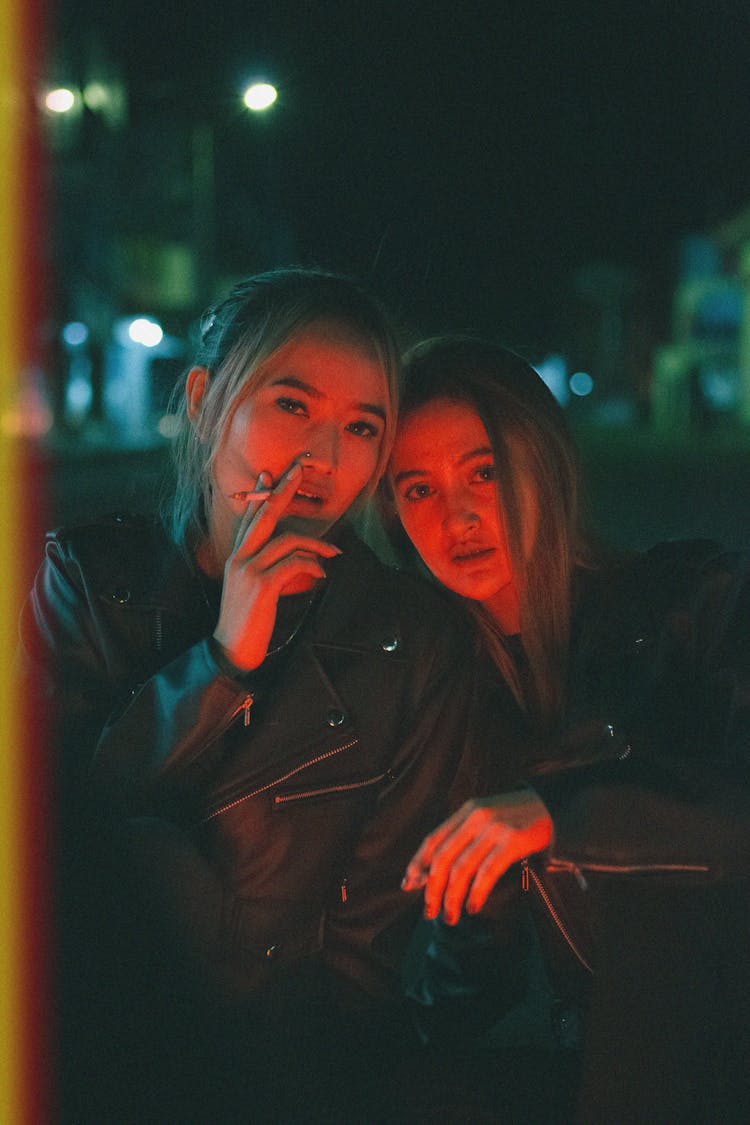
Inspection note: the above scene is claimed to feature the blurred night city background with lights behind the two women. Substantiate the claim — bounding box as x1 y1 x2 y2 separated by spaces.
14 0 750 547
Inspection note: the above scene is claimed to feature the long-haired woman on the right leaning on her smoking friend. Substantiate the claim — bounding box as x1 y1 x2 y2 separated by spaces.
386 339 750 1123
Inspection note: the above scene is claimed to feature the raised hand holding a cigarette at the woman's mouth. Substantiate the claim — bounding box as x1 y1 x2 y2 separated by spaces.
214 462 341 672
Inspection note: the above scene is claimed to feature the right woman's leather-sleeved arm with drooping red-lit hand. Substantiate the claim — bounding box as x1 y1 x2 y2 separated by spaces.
406 546 750 923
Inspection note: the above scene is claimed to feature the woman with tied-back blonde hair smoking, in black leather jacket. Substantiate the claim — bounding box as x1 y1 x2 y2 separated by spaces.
21 269 488 1122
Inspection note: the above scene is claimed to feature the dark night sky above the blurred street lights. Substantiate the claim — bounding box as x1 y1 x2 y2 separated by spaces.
56 0 750 345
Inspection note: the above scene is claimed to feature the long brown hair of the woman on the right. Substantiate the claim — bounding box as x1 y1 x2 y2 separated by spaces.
382 336 594 729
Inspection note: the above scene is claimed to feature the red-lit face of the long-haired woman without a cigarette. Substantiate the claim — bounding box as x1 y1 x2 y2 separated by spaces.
389 398 514 610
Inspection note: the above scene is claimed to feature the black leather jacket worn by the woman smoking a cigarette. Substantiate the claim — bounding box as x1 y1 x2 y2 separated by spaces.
21 516 490 997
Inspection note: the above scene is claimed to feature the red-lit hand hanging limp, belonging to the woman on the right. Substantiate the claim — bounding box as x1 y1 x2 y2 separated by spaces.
401 790 552 925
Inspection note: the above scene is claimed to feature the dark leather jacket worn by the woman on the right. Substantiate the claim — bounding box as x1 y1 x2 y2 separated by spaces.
406 540 750 1045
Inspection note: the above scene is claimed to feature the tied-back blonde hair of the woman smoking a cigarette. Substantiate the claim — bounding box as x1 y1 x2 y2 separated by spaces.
162 268 400 551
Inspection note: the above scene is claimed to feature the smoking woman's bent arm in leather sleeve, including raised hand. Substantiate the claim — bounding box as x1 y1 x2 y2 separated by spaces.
21 466 337 812
